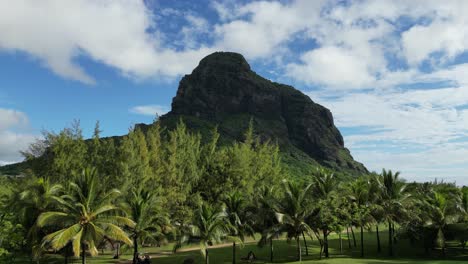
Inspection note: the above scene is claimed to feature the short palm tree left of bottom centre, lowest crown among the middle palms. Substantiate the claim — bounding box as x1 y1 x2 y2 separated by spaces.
174 202 232 264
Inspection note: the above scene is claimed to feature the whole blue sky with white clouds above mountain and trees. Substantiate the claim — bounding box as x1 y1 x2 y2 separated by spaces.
0 0 468 184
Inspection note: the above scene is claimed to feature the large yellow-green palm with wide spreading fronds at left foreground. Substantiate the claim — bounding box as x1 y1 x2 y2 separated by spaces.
37 169 135 264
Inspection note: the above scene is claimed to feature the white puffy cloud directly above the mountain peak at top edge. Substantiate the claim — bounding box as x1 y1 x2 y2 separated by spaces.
215 0 324 59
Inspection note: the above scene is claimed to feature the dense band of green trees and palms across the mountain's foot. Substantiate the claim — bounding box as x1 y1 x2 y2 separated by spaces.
0 122 468 263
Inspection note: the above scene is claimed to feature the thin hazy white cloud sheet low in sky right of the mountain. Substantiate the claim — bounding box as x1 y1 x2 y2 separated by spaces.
309 65 468 185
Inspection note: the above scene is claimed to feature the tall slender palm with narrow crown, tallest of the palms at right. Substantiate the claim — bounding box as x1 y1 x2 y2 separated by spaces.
380 169 410 256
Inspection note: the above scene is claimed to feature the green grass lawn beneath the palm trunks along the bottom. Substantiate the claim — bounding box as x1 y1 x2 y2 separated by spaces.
5 230 468 264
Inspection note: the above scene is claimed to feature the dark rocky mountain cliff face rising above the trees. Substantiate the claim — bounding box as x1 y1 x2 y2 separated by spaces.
161 52 367 175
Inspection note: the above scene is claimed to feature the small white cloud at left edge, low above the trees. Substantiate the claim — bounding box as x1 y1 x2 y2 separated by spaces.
0 108 35 165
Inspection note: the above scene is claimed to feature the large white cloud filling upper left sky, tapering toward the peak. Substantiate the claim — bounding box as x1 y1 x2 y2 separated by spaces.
0 0 212 84
